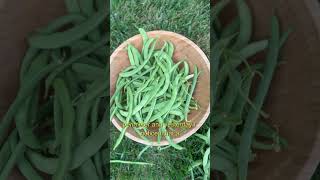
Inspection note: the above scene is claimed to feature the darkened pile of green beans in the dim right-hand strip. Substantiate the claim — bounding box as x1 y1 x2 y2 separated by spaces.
211 0 290 180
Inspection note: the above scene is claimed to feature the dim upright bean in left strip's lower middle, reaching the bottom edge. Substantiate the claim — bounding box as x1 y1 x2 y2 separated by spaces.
53 79 75 180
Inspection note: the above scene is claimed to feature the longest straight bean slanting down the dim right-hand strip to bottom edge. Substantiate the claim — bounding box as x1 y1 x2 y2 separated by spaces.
238 17 280 180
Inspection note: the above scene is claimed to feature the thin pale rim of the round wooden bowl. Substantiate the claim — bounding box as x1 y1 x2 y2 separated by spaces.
110 30 211 146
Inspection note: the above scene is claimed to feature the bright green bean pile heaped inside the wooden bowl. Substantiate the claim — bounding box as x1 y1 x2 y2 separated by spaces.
110 28 200 149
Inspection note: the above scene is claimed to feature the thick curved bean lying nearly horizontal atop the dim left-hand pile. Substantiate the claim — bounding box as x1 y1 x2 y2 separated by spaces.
29 11 107 49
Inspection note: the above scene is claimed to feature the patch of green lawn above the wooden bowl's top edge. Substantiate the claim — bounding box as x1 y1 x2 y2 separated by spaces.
110 0 210 54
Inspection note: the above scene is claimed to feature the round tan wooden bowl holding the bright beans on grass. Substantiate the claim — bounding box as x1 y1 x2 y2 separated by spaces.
110 31 210 146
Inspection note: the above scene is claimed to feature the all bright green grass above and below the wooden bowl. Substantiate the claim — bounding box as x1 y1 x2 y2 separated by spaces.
110 0 210 179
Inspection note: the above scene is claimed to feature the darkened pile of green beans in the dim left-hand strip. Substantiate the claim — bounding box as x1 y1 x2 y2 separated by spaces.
0 0 109 180
